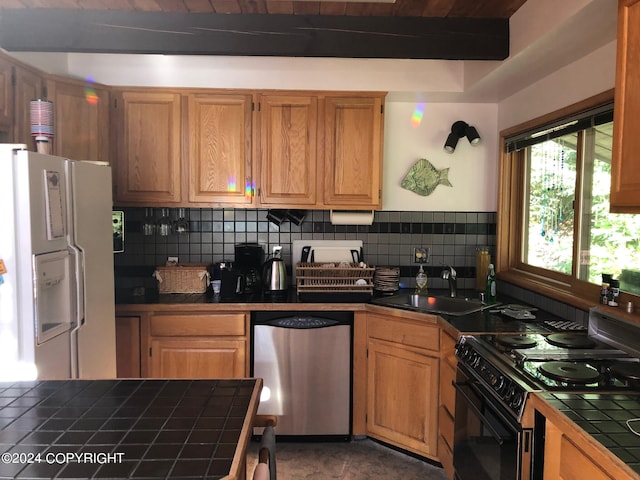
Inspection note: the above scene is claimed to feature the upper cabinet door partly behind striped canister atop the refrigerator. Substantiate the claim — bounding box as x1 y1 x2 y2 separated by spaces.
13 66 43 146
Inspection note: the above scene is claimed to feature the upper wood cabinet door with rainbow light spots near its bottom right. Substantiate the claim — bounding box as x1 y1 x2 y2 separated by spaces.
188 94 254 205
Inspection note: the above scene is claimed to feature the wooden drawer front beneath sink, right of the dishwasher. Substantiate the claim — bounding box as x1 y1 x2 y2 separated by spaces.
367 315 440 352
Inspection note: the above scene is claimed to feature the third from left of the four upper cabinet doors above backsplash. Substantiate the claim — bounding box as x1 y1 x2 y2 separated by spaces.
260 95 318 207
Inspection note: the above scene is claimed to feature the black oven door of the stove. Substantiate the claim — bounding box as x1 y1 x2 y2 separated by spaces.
453 366 533 480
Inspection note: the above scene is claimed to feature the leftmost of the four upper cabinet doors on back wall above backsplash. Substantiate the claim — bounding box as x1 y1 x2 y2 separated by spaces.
115 92 182 206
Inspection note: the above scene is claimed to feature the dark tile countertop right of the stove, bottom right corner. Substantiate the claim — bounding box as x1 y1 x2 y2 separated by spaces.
538 393 640 474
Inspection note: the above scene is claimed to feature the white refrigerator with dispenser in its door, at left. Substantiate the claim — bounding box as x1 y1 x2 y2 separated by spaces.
0 144 116 381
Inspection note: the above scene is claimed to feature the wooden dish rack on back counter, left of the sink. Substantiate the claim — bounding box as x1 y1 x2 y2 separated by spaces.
296 262 375 295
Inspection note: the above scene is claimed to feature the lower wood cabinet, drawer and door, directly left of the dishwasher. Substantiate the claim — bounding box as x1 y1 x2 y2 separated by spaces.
146 312 248 378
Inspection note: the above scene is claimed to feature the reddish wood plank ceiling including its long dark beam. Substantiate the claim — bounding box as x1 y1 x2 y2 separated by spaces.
0 0 526 60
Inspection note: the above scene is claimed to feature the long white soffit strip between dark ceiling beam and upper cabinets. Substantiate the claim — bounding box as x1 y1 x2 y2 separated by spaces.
13 52 464 94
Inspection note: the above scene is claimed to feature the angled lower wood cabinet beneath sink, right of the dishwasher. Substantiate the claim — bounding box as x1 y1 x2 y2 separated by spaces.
367 314 440 458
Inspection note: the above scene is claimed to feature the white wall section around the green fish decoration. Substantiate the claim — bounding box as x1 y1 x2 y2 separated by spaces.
382 102 498 212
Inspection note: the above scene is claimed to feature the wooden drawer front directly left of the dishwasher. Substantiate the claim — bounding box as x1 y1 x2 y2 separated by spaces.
151 313 246 337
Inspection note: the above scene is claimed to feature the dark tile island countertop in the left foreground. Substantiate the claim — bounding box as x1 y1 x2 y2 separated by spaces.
0 379 258 479
